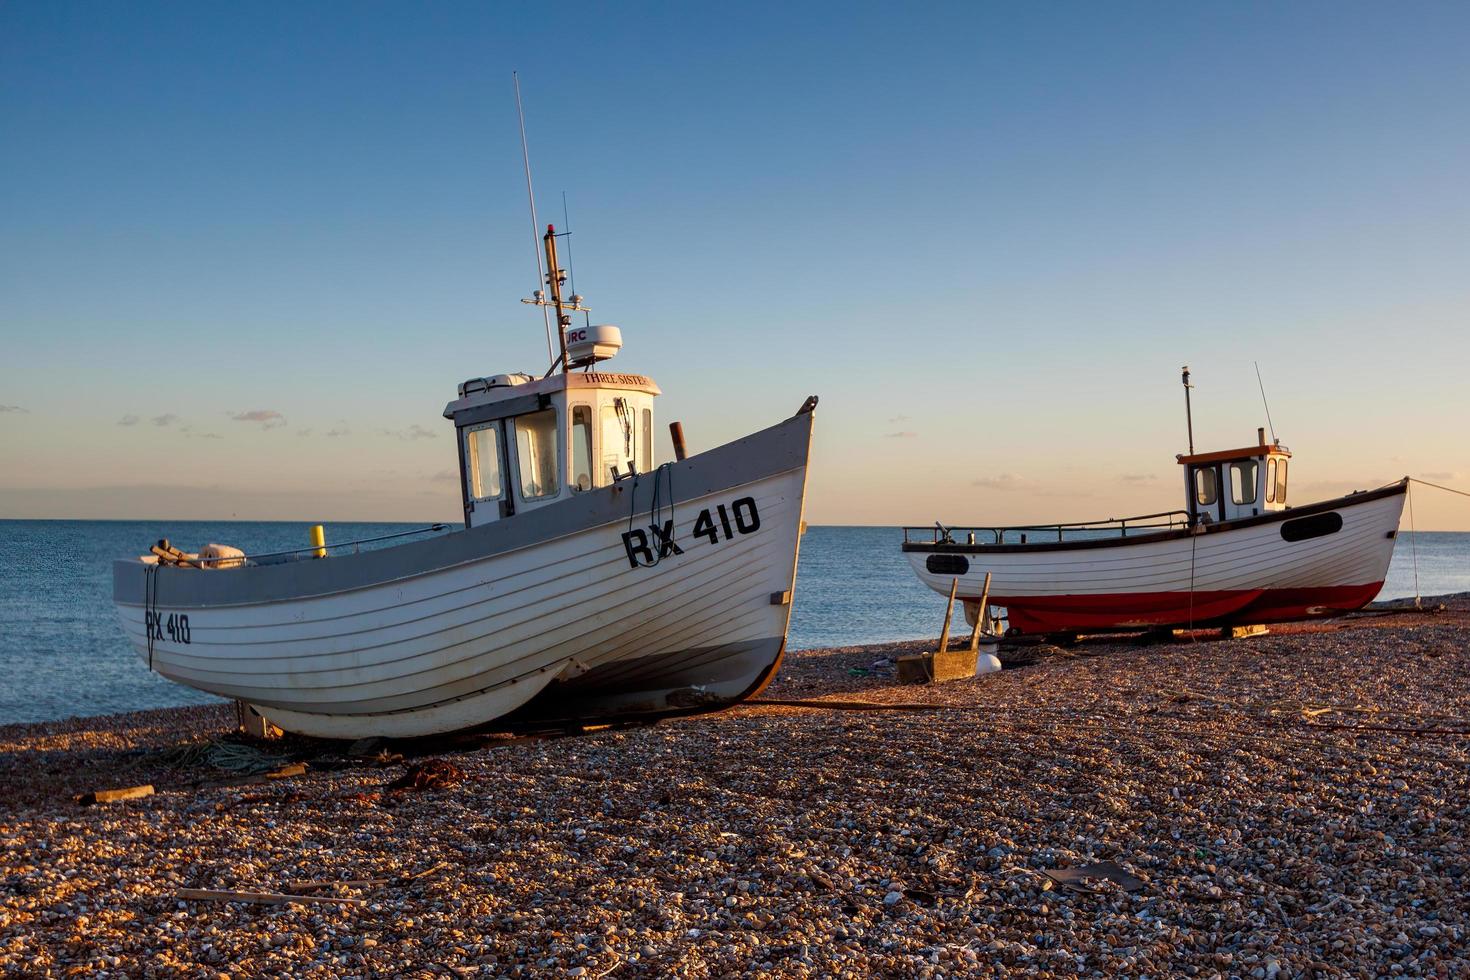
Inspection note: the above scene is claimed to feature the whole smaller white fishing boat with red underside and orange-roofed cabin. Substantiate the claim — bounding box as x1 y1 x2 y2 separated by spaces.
903 369 1408 633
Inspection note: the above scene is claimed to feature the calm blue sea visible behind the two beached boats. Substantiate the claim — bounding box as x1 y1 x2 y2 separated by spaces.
0 520 1470 724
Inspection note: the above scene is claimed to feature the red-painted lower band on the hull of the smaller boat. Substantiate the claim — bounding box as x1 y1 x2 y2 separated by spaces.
987 582 1383 633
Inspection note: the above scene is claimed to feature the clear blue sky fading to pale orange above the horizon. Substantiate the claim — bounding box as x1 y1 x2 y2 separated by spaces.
0 0 1470 529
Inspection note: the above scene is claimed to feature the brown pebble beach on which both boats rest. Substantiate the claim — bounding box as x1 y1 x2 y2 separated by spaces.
0 597 1470 977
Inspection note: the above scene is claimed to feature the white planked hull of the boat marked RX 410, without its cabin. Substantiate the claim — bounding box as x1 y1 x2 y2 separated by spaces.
113 413 811 738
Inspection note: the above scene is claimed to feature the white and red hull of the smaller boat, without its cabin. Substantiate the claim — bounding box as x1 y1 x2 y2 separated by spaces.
904 483 1407 633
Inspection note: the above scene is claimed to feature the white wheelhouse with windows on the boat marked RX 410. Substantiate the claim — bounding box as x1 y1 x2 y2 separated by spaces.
444 325 659 527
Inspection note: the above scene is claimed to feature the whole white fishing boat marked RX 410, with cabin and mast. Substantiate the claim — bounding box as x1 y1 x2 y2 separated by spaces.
113 228 816 739
